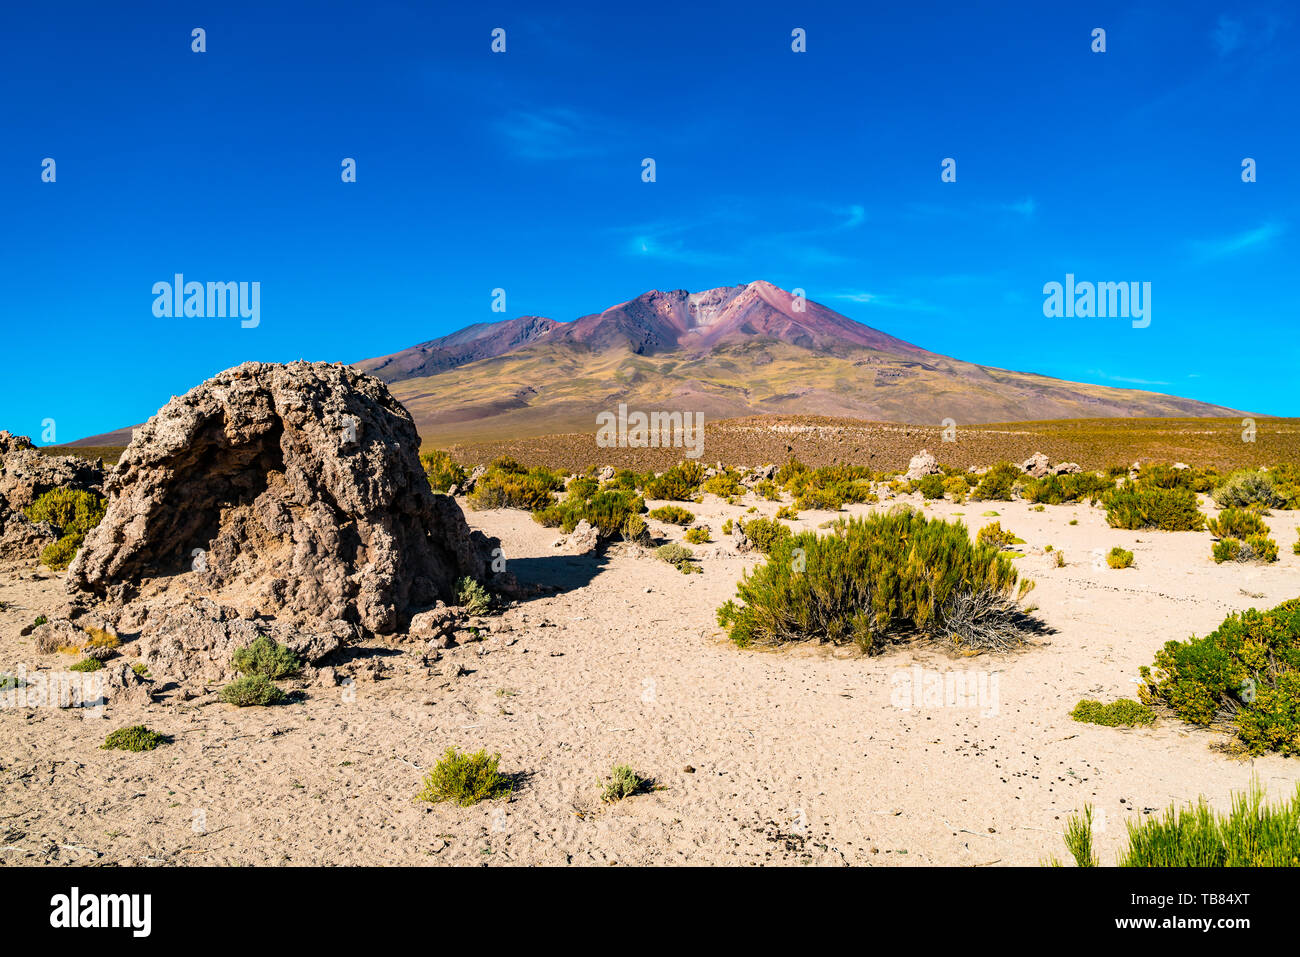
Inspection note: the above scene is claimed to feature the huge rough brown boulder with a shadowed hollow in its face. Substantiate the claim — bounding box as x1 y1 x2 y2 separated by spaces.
68 361 504 647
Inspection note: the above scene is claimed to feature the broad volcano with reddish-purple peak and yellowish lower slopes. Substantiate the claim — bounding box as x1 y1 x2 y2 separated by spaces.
361 282 1240 443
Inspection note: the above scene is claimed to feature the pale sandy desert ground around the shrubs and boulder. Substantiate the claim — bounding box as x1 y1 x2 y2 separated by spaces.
0 495 1300 866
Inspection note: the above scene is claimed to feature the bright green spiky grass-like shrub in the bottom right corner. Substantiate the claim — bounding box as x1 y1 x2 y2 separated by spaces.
1054 781 1300 867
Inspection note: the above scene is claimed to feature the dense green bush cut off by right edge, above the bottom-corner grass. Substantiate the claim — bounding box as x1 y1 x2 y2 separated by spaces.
1139 598 1300 754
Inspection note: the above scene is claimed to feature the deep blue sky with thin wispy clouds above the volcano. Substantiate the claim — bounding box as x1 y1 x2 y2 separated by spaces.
0 0 1300 441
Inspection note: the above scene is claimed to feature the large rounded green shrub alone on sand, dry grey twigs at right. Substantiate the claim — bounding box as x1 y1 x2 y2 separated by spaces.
718 510 1032 654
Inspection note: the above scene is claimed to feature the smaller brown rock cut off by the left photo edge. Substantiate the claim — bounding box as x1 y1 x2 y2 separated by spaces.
0 432 104 562
